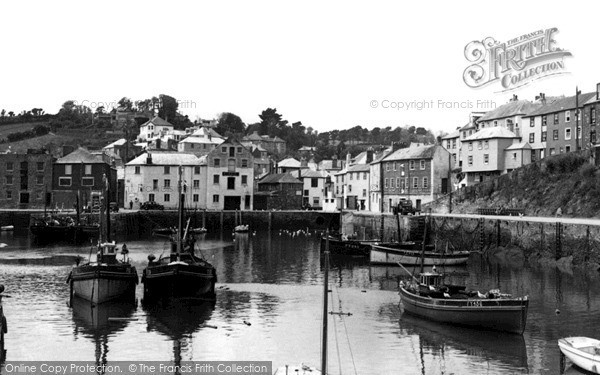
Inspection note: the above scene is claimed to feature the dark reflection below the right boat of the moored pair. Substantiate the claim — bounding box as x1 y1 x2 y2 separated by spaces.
143 299 216 366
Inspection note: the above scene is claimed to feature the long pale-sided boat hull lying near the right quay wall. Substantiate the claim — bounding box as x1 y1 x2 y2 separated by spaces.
370 244 470 266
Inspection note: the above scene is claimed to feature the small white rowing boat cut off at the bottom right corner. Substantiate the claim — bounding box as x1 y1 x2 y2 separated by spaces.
558 337 600 374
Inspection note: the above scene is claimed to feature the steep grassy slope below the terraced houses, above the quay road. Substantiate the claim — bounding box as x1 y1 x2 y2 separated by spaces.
453 153 600 218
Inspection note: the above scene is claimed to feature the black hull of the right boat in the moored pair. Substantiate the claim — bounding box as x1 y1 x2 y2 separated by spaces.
142 262 217 300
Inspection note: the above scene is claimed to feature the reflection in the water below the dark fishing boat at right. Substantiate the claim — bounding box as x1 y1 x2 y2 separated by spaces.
400 313 528 373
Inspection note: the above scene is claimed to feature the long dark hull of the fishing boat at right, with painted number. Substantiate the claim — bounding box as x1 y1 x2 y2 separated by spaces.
400 287 529 334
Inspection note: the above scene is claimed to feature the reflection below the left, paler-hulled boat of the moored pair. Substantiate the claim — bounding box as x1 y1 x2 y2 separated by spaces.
71 297 136 365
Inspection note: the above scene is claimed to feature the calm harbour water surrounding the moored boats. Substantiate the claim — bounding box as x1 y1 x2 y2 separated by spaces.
0 232 600 374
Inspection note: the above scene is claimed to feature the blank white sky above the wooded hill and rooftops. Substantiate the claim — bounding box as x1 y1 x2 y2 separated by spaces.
0 1 600 134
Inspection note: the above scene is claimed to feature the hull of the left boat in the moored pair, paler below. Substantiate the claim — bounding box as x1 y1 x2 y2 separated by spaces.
69 265 138 303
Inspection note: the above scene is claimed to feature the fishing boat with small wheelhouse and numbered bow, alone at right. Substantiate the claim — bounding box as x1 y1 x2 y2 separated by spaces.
400 270 529 334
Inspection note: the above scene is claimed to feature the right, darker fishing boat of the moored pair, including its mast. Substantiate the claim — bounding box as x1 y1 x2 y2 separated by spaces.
142 167 217 302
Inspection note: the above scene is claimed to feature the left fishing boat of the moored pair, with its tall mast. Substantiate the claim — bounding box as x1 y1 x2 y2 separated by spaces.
67 177 138 304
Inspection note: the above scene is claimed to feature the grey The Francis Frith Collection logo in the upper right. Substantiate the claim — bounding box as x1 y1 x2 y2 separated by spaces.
463 27 571 91
